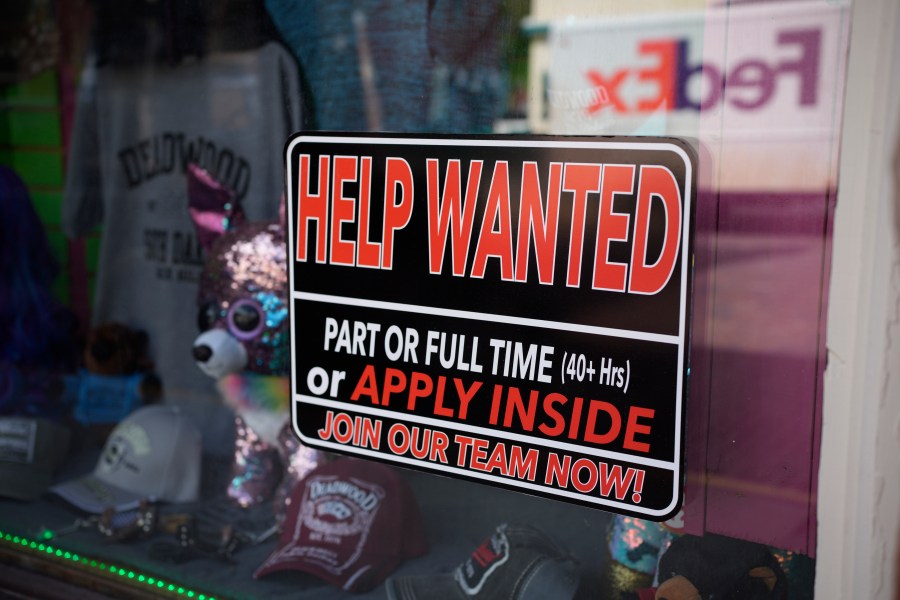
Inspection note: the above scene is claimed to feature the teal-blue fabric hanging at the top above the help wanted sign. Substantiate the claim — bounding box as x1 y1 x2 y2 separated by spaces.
265 0 515 133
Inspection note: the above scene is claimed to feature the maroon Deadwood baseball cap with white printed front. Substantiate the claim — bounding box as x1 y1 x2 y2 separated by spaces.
253 458 427 592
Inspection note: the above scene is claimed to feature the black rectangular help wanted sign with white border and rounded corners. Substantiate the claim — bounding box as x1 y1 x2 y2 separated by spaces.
286 134 696 520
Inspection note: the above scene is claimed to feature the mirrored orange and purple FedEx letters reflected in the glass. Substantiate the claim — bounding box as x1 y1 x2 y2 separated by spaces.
585 29 822 114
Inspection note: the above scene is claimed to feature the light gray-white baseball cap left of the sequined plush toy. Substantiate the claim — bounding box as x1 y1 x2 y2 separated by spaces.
50 404 202 513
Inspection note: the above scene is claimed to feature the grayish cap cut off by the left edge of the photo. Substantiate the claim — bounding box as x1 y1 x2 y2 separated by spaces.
0 417 71 500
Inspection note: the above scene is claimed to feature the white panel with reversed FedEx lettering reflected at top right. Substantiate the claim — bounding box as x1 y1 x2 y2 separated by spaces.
546 2 849 139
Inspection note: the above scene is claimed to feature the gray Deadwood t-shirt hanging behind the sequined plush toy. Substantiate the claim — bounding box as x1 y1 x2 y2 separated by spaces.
62 44 301 446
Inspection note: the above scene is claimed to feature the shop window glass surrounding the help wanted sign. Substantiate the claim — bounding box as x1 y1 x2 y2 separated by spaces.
0 0 850 600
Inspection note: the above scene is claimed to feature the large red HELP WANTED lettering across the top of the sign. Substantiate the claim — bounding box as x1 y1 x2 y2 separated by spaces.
295 154 683 295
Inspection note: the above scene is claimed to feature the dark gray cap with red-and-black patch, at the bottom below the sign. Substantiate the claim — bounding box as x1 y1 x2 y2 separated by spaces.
386 524 579 600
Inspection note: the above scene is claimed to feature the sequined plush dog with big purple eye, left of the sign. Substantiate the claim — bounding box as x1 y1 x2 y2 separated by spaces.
188 165 315 506
